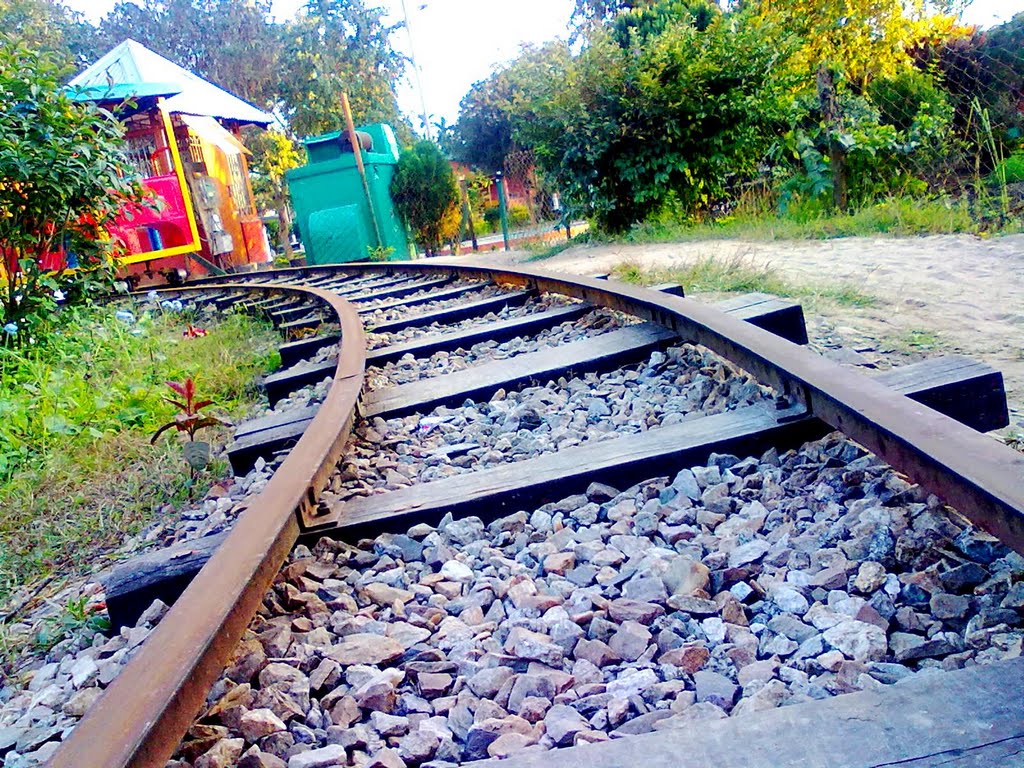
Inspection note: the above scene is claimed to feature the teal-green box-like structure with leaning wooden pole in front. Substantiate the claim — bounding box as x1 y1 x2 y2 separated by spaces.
285 123 409 264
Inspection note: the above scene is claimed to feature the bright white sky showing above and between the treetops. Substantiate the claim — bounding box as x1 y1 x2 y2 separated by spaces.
65 0 1024 126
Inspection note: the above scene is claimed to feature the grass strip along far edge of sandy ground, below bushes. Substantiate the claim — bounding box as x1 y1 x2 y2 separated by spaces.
606 198 979 243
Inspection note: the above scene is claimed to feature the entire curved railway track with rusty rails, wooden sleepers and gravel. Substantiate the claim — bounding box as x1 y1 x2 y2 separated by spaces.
32 262 1024 768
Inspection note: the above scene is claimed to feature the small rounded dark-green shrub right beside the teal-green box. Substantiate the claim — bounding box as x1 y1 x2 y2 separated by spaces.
391 141 460 256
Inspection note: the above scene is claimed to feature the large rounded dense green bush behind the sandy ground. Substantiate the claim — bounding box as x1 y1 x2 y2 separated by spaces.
517 0 793 232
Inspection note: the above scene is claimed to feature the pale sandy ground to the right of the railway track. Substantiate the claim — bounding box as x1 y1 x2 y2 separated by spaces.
446 236 1024 433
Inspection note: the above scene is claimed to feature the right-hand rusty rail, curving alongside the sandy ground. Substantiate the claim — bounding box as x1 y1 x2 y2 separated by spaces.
262 260 1024 553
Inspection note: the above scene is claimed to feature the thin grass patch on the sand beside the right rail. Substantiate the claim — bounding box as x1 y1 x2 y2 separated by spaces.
612 256 878 307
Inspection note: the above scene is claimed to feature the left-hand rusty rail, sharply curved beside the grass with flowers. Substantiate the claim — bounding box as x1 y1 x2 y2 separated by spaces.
48 284 366 768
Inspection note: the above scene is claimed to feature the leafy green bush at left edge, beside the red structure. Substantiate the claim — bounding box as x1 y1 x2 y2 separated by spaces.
0 36 141 340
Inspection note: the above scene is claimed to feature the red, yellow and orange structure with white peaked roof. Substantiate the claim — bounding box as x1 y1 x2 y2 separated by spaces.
69 40 272 286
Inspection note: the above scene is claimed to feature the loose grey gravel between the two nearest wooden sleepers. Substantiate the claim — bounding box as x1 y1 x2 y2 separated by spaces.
146 436 1024 768
